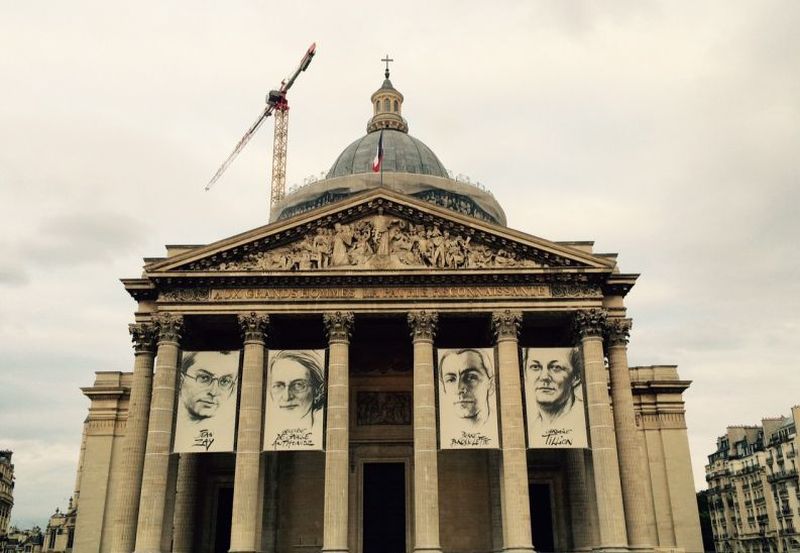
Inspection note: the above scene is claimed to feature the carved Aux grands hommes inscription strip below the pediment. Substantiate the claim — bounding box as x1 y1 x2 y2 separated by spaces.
211 285 551 301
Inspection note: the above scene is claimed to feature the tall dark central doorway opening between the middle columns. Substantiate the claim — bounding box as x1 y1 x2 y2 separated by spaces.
361 463 406 553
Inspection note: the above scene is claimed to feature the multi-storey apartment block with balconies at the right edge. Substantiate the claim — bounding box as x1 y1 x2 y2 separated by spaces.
706 406 800 553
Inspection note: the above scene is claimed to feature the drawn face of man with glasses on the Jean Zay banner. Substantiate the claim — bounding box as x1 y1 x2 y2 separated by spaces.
180 351 239 421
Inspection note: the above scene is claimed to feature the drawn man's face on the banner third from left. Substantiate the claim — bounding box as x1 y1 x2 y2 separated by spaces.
440 349 493 425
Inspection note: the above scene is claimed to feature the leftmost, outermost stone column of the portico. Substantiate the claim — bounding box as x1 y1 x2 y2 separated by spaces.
111 323 157 553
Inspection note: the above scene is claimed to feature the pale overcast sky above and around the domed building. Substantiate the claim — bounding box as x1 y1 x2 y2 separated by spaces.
0 0 800 526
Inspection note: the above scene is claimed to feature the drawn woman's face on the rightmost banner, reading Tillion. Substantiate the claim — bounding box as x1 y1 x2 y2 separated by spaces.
525 348 580 413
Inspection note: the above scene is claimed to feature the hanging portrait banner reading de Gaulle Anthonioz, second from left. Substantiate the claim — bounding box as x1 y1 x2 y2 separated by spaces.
264 349 326 451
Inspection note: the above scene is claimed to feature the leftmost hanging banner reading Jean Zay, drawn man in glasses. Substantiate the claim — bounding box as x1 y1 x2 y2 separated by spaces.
173 351 240 453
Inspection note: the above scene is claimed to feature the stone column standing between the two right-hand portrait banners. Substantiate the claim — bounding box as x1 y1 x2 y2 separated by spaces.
492 310 533 553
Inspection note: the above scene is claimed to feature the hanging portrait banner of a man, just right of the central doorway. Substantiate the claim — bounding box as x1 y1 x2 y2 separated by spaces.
436 348 500 449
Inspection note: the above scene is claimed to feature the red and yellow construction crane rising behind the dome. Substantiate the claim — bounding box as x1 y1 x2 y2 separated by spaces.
206 43 317 211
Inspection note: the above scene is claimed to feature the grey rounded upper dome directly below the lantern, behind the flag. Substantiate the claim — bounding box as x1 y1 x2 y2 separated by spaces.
326 129 448 179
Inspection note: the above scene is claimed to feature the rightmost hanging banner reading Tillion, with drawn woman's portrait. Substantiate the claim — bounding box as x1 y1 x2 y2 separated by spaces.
522 348 588 448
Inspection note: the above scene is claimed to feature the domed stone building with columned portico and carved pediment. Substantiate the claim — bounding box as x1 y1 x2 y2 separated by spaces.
75 72 702 553
